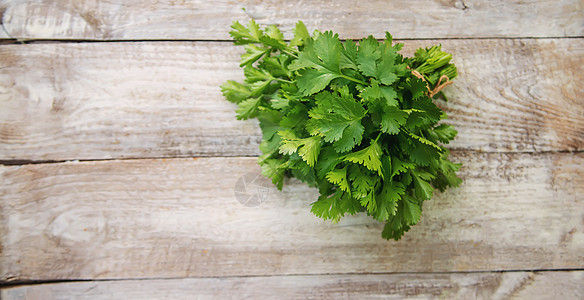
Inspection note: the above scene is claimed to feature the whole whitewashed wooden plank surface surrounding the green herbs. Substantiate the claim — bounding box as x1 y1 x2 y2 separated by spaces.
0 0 584 299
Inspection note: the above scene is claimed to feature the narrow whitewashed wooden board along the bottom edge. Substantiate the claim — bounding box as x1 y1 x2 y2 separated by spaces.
0 271 584 300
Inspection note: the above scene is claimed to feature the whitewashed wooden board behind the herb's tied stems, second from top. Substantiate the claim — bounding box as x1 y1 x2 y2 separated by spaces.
0 39 584 161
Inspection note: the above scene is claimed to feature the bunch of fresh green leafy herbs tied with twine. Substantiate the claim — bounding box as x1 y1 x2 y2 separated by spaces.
221 20 461 240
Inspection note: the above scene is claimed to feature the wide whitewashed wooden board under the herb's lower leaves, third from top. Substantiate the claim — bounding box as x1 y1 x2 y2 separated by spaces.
0 152 584 281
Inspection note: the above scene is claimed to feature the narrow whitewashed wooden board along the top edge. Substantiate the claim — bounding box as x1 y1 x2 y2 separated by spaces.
0 0 584 40
